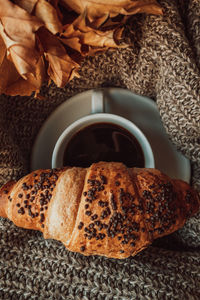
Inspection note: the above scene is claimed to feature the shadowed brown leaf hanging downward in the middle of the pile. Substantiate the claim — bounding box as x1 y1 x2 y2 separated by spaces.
38 27 80 87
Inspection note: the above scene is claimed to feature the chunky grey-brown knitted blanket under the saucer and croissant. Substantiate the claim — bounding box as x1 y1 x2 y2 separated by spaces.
0 0 200 300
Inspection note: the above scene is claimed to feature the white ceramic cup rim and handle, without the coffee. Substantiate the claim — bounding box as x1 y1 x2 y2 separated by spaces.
52 90 155 168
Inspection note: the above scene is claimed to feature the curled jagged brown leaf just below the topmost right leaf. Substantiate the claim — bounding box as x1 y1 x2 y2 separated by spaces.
61 13 123 56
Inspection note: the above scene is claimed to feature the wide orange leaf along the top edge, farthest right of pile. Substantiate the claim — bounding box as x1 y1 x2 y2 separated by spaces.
61 0 162 27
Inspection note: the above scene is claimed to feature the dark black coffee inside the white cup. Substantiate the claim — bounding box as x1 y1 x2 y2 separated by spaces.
63 123 144 168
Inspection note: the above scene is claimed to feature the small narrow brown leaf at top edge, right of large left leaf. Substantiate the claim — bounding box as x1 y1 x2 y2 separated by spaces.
15 0 62 34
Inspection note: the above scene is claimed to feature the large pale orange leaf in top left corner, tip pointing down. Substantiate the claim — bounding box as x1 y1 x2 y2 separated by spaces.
0 0 43 79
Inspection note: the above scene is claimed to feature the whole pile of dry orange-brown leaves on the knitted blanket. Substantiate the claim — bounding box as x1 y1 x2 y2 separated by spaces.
0 0 162 95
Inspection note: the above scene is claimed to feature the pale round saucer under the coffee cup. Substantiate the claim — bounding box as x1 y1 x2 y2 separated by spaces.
31 88 191 182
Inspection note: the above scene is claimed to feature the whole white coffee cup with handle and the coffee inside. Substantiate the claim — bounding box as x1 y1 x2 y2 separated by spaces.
52 89 155 168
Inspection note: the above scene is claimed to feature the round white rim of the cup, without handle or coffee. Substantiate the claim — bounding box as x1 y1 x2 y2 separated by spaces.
51 113 155 168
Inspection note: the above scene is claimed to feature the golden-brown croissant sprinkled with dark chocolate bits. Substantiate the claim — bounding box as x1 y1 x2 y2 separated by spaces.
0 162 200 259
